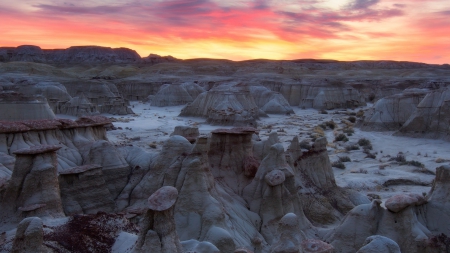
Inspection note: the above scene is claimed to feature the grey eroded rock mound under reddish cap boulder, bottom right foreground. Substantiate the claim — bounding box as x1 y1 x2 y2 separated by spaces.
326 197 431 252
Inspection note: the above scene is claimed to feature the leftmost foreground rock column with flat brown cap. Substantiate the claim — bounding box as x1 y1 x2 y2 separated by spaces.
0 145 64 220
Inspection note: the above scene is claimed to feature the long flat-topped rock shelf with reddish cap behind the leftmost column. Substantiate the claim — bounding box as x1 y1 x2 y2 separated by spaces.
0 116 131 213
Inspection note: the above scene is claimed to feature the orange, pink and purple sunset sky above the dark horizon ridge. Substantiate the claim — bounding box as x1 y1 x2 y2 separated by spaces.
0 0 450 64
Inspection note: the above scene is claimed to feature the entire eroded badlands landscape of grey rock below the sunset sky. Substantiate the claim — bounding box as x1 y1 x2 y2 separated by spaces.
0 46 450 253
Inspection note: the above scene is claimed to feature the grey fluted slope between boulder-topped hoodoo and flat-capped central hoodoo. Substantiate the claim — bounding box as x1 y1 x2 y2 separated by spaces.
175 138 267 253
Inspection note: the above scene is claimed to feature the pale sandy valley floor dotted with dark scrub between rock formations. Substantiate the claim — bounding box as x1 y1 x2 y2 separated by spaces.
105 102 450 199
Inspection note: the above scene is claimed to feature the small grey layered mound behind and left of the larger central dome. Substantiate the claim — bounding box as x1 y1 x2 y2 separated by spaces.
150 83 205 107
